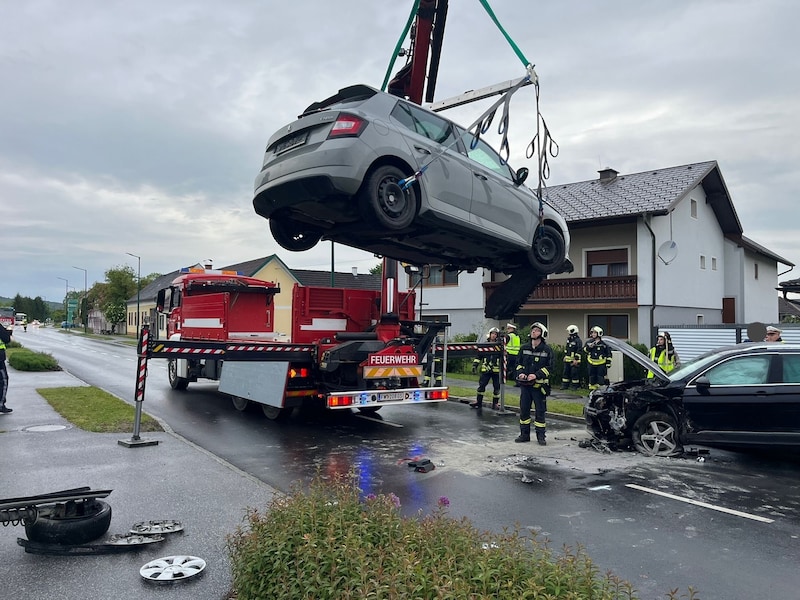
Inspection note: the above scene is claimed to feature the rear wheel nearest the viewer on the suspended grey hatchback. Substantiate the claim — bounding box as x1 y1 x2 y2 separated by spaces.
360 165 417 231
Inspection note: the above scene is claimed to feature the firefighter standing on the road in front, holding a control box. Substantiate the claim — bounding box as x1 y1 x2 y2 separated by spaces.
514 321 554 446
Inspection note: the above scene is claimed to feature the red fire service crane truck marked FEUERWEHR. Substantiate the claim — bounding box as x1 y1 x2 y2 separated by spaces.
144 261 468 419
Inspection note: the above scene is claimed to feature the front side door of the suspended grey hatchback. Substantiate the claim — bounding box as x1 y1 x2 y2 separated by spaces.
462 132 538 250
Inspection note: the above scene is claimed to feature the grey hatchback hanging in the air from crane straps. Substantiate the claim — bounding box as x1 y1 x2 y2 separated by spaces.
253 85 572 274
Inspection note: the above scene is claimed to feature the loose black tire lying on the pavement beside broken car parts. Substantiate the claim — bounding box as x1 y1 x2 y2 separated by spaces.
25 500 111 545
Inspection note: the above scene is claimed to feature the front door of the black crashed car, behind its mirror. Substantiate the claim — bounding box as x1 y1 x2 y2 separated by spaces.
683 352 777 445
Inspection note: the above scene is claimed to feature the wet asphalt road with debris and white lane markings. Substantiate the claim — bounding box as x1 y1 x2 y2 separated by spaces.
18 329 800 600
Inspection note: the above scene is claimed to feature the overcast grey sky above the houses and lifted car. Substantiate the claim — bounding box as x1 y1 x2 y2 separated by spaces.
0 0 800 301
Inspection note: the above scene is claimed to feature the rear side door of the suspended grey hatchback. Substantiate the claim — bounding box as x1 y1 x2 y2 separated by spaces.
392 101 472 227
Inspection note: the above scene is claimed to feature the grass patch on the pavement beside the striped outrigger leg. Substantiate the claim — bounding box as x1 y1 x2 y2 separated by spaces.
36 387 164 433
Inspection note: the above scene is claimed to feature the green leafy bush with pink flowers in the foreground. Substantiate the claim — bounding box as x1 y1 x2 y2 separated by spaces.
227 473 637 600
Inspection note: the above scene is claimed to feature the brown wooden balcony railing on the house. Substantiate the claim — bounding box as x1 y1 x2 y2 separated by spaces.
483 275 637 308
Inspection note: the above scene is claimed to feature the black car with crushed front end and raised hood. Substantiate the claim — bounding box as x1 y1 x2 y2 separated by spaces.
584 336 800 456
